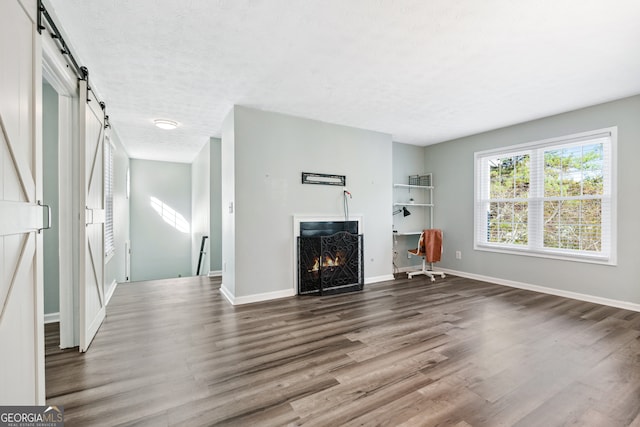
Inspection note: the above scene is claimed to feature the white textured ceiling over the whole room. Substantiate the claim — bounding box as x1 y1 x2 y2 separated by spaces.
48 0 640 162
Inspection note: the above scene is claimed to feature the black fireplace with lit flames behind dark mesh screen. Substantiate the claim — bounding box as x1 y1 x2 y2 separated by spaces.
298 221 364 295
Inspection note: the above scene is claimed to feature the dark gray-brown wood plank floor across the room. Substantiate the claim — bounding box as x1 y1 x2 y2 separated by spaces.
46 277 640 427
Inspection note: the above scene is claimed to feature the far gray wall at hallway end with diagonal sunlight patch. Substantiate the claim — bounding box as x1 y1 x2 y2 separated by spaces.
130 159 191 281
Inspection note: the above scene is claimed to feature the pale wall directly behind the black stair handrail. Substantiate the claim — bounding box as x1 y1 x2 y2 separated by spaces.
191 144 211 276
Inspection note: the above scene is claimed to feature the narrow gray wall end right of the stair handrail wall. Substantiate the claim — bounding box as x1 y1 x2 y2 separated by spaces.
209 138 222 273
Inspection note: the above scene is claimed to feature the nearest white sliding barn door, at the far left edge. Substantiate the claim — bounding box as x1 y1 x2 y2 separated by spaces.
0 0 45 405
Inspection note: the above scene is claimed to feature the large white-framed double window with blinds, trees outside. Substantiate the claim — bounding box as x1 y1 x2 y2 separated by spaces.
474 128 617 264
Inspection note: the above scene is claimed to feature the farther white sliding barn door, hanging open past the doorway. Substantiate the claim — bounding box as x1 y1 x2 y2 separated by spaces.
78 80 106 351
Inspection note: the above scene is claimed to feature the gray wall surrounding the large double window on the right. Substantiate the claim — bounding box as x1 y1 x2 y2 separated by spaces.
425 96 640 304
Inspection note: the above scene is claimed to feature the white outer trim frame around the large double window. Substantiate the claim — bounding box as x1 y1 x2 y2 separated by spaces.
473 126 618 265
